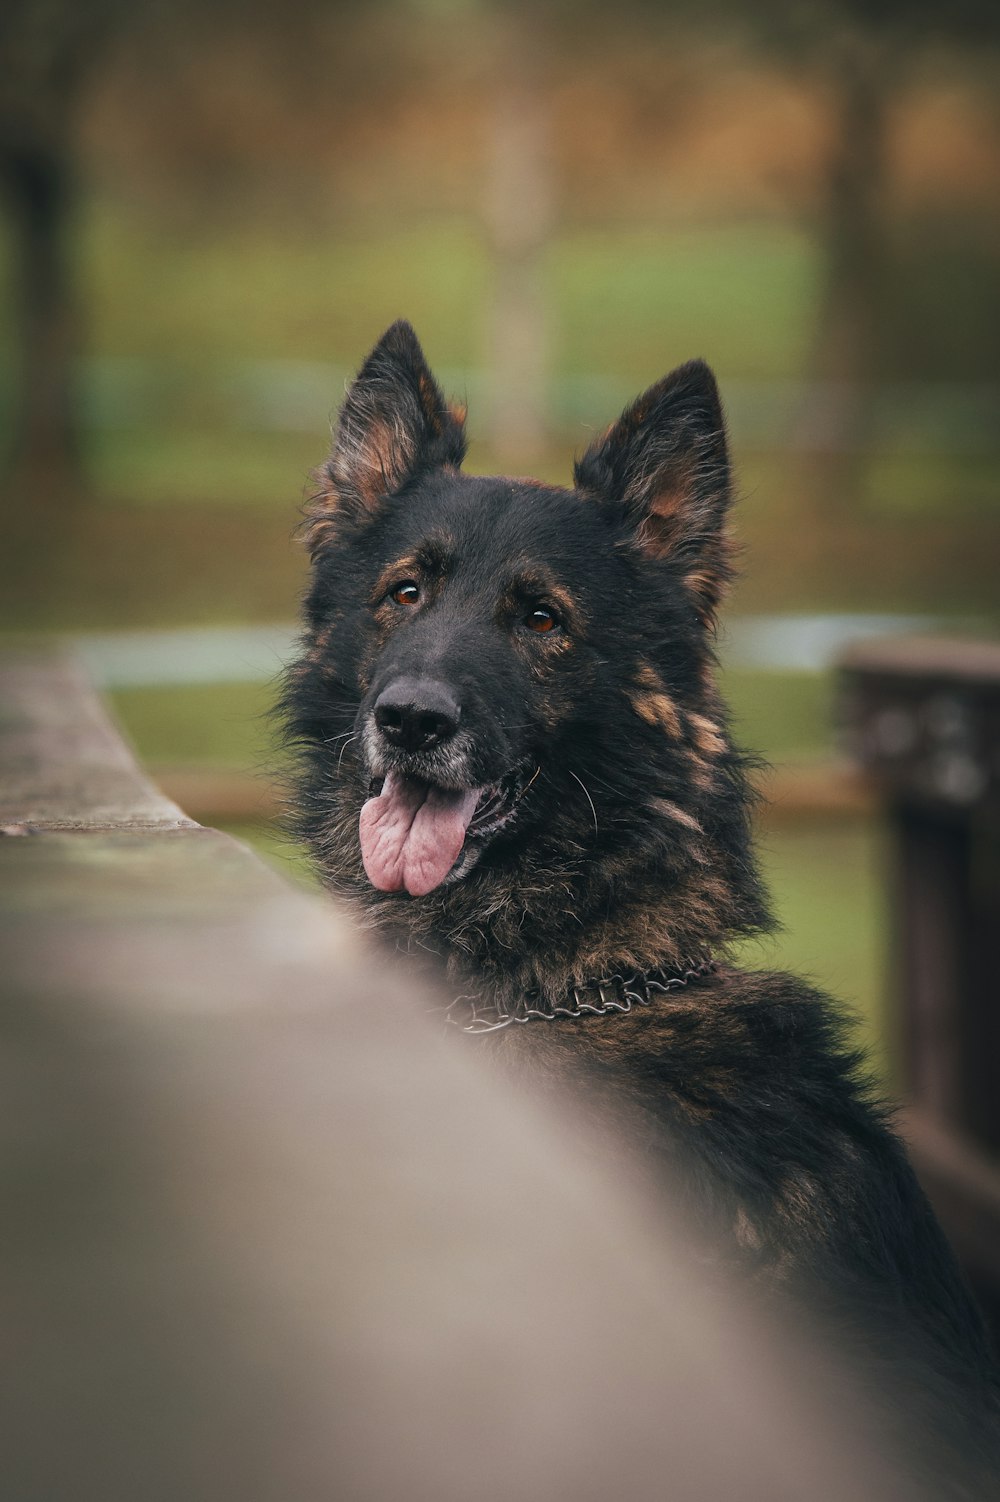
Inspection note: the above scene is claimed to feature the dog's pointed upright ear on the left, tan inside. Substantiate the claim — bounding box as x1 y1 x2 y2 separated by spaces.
309 320 465 545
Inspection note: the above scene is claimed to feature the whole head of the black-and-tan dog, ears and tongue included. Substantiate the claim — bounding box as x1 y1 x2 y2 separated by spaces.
288 323 759 961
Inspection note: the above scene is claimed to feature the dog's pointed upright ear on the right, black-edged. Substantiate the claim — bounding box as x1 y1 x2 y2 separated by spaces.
575 360 731 625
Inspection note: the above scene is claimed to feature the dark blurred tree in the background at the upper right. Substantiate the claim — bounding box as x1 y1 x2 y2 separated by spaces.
751 0 1000 509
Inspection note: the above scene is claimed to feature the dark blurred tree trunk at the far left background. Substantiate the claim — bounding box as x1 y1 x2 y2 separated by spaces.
0 0 132 506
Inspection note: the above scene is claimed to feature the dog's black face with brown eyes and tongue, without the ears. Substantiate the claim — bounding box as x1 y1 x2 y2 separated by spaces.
349 472 620 897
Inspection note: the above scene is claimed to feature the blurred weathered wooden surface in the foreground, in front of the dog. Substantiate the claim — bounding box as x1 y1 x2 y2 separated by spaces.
0 658 966 1502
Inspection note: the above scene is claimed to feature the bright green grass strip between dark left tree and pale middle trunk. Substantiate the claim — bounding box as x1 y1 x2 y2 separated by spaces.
83 211 488 366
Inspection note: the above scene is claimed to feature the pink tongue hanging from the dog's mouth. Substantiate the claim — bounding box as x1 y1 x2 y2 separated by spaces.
359 772 479 897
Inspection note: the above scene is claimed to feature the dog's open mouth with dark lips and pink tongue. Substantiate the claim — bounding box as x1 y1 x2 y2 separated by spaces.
359 772 526 897
